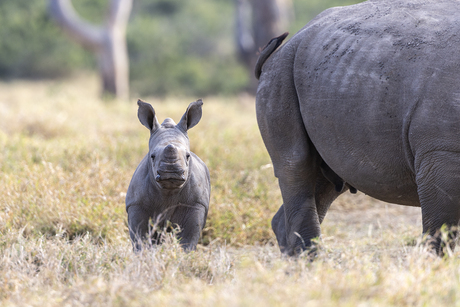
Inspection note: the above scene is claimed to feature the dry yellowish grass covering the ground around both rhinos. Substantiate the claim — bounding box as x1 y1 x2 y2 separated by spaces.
0 76 460 306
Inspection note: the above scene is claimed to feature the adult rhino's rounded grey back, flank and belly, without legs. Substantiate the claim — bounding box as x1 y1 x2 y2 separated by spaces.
276 1 460 205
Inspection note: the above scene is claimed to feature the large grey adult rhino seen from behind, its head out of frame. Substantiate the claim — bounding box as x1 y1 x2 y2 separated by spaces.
256 0 460 255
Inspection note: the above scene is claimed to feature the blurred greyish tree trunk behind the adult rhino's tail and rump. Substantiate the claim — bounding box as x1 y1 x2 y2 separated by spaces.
235 0 294 93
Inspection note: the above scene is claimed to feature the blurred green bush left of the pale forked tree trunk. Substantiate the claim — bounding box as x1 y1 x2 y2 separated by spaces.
0 0 91 79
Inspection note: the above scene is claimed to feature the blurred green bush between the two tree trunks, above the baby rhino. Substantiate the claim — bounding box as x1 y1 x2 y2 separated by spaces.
128 0 249 96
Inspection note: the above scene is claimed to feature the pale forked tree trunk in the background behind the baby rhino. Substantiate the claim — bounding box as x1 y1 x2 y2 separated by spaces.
49 0 132 99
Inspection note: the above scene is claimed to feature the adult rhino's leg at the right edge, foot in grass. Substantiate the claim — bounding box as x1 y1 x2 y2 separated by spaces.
416 151 460 256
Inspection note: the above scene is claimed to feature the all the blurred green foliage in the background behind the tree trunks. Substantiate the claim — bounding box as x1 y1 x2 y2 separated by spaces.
0 0 361 96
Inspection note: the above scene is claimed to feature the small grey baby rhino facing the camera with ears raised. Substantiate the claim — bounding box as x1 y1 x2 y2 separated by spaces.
126 99 211 250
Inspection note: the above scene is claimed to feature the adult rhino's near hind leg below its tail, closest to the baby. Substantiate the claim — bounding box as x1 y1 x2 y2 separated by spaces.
256 56 321 255
